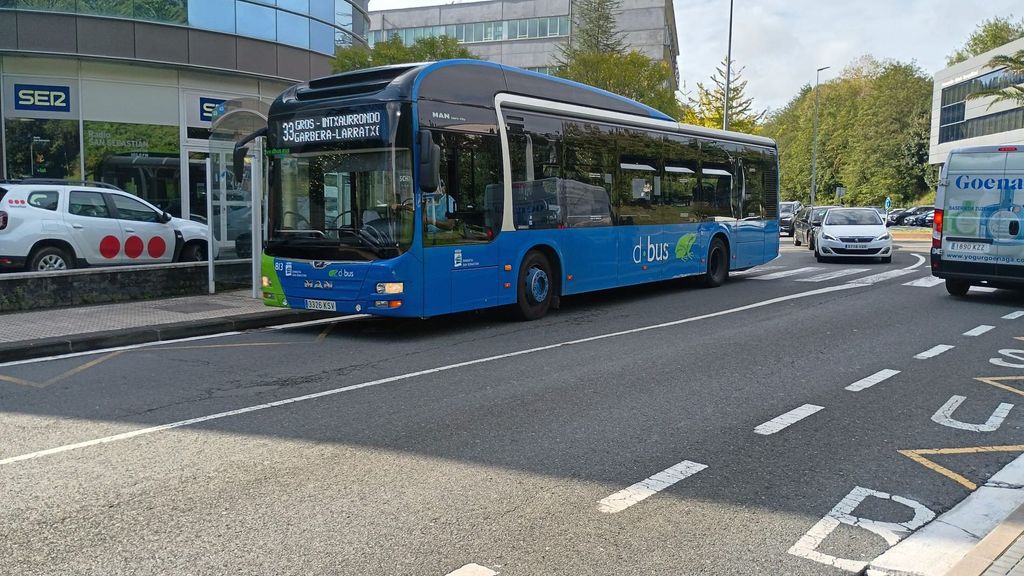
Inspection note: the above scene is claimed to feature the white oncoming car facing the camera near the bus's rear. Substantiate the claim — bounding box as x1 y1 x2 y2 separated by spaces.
814 208 893 263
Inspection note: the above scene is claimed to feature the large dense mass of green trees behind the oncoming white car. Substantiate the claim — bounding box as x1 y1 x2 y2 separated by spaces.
764 56 932 205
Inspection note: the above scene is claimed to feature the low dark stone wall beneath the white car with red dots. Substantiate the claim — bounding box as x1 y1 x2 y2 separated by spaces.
0 260 252 312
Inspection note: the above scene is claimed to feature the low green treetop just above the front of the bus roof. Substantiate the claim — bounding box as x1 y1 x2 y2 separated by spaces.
331 36 477 72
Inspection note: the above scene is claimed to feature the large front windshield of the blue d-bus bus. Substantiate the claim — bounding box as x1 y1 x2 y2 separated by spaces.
266 148 415 260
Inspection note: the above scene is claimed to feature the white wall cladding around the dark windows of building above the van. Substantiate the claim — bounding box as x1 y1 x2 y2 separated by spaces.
928 38 1024 164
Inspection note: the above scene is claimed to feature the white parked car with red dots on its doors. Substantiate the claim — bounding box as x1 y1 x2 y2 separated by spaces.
0 179 207 271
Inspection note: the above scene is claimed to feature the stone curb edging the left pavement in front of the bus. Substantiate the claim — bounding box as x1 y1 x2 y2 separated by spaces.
0 310 340 362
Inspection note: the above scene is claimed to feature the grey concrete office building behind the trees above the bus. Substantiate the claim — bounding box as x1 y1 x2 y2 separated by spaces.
368 0 679 84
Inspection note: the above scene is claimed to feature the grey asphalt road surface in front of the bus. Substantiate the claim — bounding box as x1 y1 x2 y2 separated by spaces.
0 235 1024 576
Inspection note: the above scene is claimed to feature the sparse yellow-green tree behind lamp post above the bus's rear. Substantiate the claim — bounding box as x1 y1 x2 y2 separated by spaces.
683 58 767 133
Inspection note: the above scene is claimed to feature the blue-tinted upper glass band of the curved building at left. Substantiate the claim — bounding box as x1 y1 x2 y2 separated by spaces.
0 0 370 55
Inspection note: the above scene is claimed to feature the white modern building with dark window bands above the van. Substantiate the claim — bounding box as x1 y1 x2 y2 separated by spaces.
928 38 1024 164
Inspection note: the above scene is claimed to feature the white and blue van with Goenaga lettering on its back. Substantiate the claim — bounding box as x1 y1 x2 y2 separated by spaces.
932 145 1024 296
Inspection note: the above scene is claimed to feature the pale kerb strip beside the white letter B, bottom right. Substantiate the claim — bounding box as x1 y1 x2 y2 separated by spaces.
867 455 1024 576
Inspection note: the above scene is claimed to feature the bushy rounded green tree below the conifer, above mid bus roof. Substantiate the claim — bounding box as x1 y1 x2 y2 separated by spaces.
557 50 682 118
